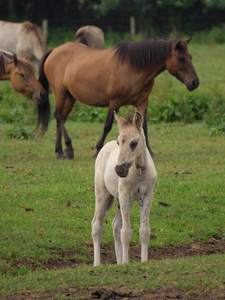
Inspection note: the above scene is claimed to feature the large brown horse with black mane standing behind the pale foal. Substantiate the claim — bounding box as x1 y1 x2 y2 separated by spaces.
39 39 199 158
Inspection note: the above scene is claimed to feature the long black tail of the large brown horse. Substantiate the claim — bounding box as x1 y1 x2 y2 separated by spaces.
33 49 53 136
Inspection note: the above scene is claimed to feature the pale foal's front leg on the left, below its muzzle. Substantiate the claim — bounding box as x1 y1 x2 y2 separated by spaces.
119 189 132 263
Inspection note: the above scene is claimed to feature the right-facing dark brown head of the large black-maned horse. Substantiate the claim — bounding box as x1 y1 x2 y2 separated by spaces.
166 38 199 91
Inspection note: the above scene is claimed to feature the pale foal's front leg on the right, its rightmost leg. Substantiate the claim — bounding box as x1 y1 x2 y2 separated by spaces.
139 192 153 262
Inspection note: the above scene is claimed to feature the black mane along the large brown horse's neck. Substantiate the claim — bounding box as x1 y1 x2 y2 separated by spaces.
114 39 178 69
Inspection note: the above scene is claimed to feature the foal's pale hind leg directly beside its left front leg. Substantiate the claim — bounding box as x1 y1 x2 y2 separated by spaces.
112 208 123 265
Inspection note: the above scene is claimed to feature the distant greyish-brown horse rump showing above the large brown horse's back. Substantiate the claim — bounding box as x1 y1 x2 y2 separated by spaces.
74 26 105 49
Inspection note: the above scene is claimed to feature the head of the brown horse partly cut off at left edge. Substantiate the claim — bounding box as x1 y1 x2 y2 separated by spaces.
8 55 47 104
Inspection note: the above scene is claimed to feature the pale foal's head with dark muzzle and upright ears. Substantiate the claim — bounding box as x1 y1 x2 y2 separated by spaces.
115 112 146 177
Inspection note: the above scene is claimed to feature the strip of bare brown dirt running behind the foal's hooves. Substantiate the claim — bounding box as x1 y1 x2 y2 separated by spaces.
6 238 225 273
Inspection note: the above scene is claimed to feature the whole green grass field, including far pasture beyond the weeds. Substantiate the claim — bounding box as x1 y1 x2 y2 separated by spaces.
0 39 225 299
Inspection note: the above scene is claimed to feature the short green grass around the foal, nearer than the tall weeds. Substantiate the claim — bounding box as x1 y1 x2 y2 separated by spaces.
0 121 225 294
